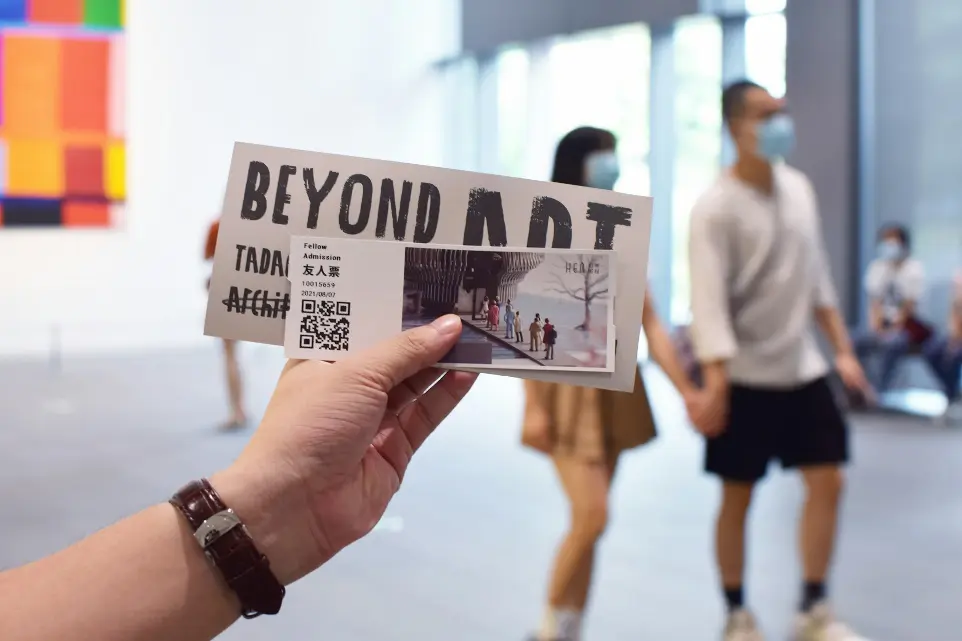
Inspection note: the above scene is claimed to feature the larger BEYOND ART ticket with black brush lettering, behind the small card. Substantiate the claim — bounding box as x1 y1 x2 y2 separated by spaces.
204 143 652 392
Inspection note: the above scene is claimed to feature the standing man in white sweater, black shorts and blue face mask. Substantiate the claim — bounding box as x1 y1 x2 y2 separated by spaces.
689 81 871 641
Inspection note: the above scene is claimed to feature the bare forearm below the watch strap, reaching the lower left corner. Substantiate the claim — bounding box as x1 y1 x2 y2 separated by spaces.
0 504 240 641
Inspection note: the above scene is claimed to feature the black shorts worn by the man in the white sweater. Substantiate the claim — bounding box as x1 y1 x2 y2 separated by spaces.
705 378 849 482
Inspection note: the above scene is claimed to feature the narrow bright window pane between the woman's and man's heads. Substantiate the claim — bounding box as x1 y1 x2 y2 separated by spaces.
670 16 722 324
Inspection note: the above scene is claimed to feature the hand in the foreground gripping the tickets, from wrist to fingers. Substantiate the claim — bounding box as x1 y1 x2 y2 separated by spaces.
211 315 477 585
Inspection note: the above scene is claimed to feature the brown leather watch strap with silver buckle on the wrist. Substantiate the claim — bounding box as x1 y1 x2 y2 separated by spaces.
170 479 285 619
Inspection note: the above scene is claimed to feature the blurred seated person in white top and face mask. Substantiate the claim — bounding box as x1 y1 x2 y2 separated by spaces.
855 225 932 392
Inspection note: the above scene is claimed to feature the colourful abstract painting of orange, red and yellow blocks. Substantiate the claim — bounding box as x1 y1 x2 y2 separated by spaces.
0 0 126 231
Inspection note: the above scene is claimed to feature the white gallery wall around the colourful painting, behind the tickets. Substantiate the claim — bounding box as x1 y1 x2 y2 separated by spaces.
0 0 460 356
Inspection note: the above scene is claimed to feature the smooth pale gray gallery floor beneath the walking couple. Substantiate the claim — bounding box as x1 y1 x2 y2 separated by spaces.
0 344 962 641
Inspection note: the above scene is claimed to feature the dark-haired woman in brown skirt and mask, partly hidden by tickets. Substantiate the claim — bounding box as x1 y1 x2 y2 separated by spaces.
522 127 698 641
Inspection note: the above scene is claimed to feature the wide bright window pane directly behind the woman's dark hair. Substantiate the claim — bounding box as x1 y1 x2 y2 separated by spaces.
492 24 651 194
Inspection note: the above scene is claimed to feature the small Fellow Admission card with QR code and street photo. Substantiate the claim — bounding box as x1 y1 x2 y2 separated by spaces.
284 236 615 372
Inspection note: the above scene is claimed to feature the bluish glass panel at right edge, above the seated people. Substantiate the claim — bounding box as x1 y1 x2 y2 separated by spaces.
861 0 962 320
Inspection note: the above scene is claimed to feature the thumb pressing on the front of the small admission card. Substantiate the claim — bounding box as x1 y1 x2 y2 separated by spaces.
343 314 461 392
